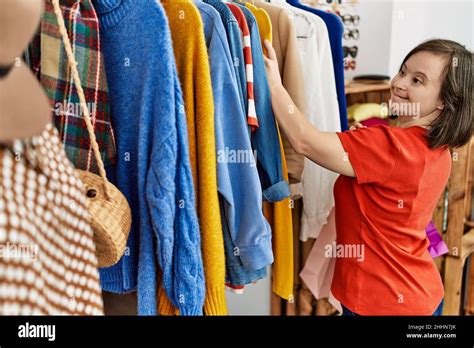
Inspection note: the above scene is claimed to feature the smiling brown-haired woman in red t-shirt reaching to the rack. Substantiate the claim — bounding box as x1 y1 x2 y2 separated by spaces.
265 39 473 315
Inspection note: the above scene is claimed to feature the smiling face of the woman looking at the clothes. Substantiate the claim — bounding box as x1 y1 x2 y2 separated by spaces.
390 51 448 118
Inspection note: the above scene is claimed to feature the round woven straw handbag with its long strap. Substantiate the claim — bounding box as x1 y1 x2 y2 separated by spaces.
52 0 132 267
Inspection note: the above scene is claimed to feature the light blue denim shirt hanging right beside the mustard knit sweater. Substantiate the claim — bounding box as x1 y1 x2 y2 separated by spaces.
195 1 273 272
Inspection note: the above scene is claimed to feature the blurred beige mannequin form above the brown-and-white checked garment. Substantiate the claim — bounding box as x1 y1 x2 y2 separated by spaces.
0 0 51 143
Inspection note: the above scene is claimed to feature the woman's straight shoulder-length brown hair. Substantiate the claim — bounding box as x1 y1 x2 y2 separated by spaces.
400 39 474 148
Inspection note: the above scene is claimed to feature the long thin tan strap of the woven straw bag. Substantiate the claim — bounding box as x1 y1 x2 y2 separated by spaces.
52 0 110 199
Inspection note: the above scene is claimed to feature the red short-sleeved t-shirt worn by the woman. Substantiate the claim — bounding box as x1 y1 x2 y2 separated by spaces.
331 125 451 315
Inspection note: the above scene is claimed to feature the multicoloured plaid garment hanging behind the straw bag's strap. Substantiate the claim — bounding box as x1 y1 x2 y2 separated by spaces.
28 0 116 173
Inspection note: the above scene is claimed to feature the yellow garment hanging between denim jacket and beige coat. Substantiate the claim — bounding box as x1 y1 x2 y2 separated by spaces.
246 3 294 300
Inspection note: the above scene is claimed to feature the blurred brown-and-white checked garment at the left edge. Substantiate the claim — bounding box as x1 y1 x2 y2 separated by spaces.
0 124 103 315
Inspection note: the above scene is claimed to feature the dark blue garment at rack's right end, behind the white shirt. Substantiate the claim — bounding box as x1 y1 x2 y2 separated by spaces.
287 0 348 131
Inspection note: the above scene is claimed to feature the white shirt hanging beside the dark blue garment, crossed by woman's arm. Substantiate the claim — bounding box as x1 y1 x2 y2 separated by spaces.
278 3 341 241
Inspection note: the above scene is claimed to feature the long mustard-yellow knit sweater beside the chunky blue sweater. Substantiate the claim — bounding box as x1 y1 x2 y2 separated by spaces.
157 0 227 315
